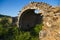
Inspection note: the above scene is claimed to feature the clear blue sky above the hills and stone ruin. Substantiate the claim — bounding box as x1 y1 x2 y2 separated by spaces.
0 0 60 17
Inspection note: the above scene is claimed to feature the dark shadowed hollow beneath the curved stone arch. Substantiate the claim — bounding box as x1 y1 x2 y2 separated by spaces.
19 9 43 30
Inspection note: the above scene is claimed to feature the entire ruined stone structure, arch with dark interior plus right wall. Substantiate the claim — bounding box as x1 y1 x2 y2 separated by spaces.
17 2 60 40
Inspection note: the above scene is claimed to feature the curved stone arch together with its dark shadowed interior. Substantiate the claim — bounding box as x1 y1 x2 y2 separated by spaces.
18 2 51 29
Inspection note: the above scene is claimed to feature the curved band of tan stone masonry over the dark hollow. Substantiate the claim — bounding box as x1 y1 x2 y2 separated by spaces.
18 2 51 26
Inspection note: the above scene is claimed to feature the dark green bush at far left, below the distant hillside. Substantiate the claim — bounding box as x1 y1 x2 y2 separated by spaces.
0 17 19 40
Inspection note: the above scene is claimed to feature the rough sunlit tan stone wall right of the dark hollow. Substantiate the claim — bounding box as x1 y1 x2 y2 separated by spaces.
39 7 60 40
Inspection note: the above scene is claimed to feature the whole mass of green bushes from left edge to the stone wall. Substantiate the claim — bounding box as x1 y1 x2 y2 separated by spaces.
0 17 43 40
